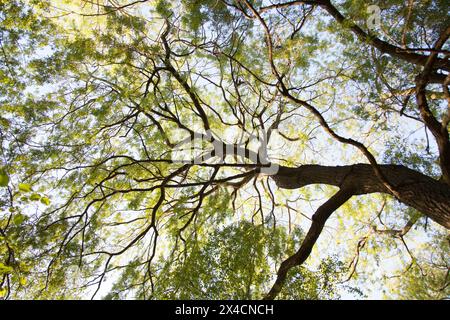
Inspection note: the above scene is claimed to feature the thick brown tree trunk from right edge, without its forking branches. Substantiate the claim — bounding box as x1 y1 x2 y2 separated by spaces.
272 164 450 229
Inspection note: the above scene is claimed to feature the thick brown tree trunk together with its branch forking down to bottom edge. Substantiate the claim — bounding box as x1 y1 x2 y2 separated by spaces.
264 164 450 300
